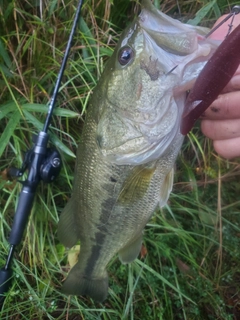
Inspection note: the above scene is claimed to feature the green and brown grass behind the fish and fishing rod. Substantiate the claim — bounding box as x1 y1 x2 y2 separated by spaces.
0 0 240 320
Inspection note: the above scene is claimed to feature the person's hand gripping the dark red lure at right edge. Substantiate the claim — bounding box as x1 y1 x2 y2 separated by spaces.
201 14 240 159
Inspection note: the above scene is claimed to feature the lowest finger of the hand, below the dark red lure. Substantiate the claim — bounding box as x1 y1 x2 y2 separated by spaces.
213 137 240 159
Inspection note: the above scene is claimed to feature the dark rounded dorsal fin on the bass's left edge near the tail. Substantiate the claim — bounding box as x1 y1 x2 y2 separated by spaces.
58 198 78 248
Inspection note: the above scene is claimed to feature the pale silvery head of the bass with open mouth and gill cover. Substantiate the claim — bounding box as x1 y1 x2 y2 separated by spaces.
96 1 216 165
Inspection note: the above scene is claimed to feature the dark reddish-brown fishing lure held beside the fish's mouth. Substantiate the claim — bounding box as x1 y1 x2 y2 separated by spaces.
180 21 240 135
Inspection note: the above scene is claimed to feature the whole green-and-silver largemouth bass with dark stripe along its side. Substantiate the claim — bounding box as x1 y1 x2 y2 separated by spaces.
58 1 218 301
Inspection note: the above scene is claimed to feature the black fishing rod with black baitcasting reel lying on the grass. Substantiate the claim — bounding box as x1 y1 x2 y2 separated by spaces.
0 0 83 308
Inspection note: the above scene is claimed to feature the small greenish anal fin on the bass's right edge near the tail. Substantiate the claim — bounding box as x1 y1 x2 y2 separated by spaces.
118 232 142 263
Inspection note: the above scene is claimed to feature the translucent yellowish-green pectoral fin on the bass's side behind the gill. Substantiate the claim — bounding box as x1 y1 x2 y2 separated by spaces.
118 166 156 204
